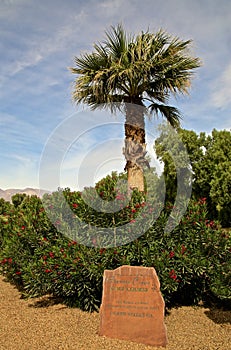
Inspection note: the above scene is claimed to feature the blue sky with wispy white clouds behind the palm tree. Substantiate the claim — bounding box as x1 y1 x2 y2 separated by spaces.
0 0 231 190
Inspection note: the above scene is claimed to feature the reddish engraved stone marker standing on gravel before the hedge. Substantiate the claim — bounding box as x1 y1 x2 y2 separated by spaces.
99 265 167 346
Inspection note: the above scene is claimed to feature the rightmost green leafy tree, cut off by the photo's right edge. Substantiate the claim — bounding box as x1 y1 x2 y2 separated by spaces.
194 129 231 226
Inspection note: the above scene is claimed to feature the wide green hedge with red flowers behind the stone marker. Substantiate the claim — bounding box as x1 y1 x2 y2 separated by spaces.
0 173 231 311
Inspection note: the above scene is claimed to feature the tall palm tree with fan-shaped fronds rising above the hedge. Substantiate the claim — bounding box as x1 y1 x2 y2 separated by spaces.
71 25 200 191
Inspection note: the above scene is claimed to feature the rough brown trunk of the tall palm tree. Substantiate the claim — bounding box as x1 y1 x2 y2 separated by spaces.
123 103 149 192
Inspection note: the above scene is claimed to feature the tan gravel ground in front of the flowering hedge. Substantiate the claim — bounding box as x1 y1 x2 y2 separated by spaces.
0 276 231 350
